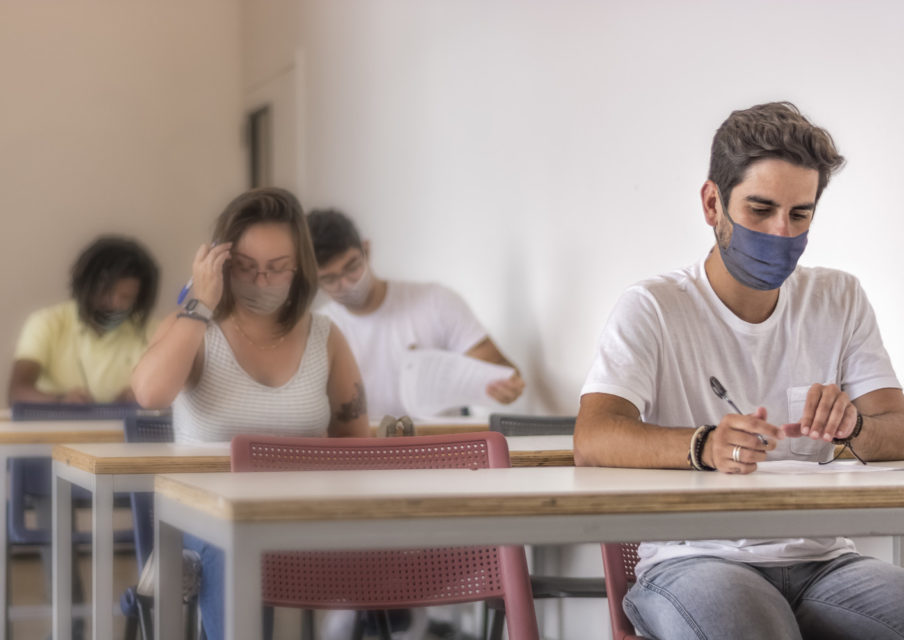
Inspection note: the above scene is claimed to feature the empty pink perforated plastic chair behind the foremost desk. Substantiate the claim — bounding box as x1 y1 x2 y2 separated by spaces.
232 432 538 640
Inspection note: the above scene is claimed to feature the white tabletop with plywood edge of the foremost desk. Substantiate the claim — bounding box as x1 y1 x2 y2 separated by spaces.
155 462 904 521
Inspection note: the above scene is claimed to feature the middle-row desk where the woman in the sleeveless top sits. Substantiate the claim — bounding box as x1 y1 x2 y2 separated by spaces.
53 436 573 639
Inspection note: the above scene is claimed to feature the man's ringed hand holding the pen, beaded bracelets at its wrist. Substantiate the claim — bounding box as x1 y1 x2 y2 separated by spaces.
703 407 785 473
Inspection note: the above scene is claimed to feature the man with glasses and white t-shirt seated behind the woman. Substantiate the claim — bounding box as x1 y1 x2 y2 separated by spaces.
308 209 524 418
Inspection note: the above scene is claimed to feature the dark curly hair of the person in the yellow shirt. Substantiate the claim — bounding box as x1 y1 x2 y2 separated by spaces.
70 235 160 327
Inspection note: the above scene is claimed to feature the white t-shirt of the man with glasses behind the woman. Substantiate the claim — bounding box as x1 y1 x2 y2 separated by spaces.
319 280 487 418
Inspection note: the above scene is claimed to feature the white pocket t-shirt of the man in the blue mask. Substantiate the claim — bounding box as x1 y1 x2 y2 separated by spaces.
581 261 901 574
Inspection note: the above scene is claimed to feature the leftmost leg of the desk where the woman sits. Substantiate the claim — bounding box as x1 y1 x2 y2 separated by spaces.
52 462 72 640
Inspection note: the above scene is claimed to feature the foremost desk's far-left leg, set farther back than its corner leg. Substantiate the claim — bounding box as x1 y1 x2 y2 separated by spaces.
154 505 184 640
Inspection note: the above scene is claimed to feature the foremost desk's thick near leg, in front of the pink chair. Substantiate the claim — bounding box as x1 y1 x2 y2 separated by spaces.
223 524 263 640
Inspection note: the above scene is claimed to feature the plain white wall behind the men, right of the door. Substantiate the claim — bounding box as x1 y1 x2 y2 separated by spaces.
298 0 904 413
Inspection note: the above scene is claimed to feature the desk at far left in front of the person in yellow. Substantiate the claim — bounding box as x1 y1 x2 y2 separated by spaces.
0 420 123 640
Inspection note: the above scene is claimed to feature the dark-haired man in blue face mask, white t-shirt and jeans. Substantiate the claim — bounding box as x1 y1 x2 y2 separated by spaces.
575 103 904 639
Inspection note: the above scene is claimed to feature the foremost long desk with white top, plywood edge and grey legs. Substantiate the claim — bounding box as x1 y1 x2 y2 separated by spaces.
155 462 904 640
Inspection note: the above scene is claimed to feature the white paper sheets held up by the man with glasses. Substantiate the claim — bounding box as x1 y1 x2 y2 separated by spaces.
399 349 515 417
